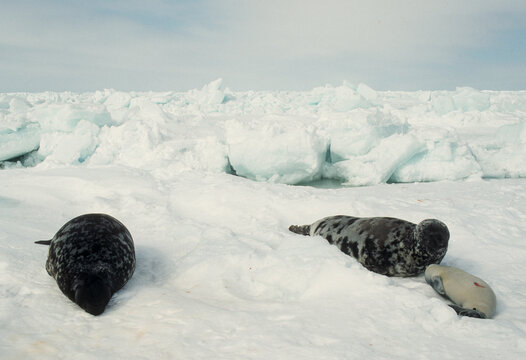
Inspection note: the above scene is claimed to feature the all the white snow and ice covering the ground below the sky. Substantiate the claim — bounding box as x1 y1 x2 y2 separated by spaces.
0 80 526 359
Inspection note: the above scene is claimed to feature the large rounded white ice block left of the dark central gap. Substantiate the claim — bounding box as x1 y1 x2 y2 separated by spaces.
225 115 328 184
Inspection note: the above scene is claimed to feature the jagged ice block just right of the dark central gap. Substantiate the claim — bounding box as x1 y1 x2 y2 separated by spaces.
317 109 423 186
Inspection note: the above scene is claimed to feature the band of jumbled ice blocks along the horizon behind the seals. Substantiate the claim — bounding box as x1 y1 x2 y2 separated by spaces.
0 79 526 186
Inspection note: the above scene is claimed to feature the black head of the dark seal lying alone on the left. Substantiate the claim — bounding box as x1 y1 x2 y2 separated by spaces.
74 274 112 315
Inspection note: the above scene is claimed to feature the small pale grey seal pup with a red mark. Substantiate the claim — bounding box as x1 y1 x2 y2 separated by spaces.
425 265 497 319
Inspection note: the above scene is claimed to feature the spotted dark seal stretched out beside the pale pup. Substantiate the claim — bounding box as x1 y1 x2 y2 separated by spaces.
289 215 449 276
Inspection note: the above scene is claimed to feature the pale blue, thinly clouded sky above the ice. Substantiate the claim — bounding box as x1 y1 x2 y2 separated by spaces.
0 0 526 92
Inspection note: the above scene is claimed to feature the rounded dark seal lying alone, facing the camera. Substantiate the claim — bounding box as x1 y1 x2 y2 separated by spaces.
36 214 135 315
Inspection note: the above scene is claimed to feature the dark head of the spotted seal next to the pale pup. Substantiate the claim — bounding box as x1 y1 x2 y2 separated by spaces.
415 219 449 260
